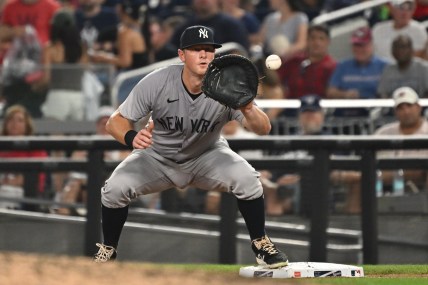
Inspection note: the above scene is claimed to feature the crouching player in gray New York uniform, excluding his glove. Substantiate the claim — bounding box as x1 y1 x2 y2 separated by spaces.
94 26 288 268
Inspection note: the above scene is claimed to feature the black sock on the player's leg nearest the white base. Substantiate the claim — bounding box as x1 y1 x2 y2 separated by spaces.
238 195 266 240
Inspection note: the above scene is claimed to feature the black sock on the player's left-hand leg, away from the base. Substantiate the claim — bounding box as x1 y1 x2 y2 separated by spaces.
101 205 129 249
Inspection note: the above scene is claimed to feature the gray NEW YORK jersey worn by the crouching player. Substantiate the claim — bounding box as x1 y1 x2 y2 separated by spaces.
119 64 243 162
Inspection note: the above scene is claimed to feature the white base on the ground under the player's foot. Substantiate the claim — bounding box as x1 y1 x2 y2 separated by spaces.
239 262 364 278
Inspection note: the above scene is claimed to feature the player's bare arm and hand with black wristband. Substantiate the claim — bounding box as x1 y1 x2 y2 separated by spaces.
106 110 154 148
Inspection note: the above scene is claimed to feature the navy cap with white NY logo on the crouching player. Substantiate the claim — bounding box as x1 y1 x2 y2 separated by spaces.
180 26 221 50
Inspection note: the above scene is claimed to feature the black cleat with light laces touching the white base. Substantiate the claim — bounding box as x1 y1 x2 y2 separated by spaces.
251 235 288 268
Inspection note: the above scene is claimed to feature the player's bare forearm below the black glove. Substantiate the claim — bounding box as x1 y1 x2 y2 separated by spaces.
241 102 271 135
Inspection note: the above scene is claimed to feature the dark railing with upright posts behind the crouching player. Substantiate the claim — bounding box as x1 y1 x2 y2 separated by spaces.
0 136 428 264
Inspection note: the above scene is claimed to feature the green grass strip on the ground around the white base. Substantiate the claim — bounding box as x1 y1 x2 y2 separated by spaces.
158 264 428 285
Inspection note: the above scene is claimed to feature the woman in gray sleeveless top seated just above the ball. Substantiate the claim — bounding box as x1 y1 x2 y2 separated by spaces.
260 0 308 58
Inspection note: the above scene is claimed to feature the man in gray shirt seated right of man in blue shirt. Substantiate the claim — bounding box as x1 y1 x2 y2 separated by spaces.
378 35 428 98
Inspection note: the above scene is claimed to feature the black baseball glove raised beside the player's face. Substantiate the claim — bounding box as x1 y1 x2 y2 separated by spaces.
202 54 259 109
